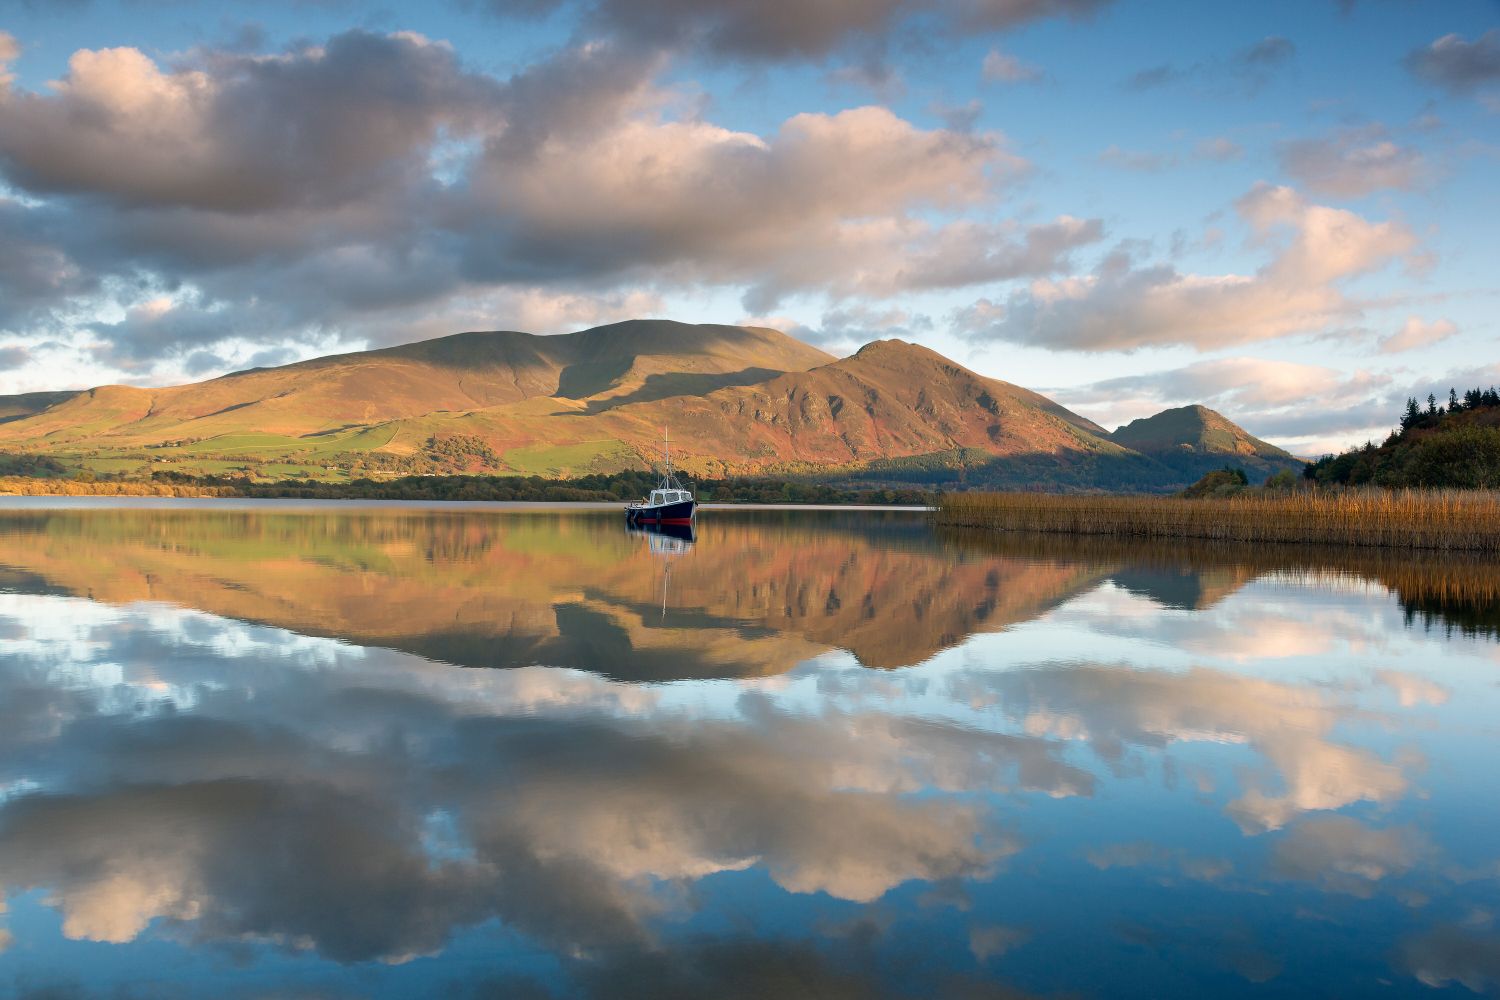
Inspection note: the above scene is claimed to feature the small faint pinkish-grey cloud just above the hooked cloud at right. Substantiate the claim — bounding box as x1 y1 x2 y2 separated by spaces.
1277 124 1428 198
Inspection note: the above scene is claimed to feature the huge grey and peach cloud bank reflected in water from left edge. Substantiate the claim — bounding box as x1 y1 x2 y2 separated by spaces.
0 597 1094 961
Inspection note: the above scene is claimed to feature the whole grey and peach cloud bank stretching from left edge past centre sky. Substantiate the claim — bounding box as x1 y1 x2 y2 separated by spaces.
0 30 1101 367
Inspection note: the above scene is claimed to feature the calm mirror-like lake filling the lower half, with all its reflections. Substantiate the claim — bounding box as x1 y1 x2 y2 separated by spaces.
0 501 1500 999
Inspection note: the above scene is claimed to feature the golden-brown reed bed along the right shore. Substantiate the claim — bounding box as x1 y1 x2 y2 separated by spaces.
936 490 1500 553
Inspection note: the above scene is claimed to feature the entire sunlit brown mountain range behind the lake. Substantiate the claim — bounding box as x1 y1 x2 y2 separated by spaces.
0 319 1301 490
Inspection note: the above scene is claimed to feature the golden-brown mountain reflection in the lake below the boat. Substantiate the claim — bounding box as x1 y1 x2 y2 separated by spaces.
0 511 1116 679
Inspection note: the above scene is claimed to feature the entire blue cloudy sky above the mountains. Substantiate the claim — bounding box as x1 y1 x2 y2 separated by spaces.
0 0 1500 454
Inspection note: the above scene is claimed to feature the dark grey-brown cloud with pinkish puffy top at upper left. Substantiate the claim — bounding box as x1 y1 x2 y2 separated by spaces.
0 31 500 213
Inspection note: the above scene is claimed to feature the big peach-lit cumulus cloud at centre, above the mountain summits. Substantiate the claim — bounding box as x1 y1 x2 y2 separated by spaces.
464 106 1056 310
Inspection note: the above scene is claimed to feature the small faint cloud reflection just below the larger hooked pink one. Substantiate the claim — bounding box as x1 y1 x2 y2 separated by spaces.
1271 816 1431 897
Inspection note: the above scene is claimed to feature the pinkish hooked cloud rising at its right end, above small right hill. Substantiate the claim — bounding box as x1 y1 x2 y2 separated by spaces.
956 184 1416 351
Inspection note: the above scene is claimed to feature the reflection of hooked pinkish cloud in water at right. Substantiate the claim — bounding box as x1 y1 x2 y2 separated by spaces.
951 666 1407 832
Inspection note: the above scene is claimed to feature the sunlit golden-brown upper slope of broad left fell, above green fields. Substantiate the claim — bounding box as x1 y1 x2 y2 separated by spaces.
0 319 833 447
